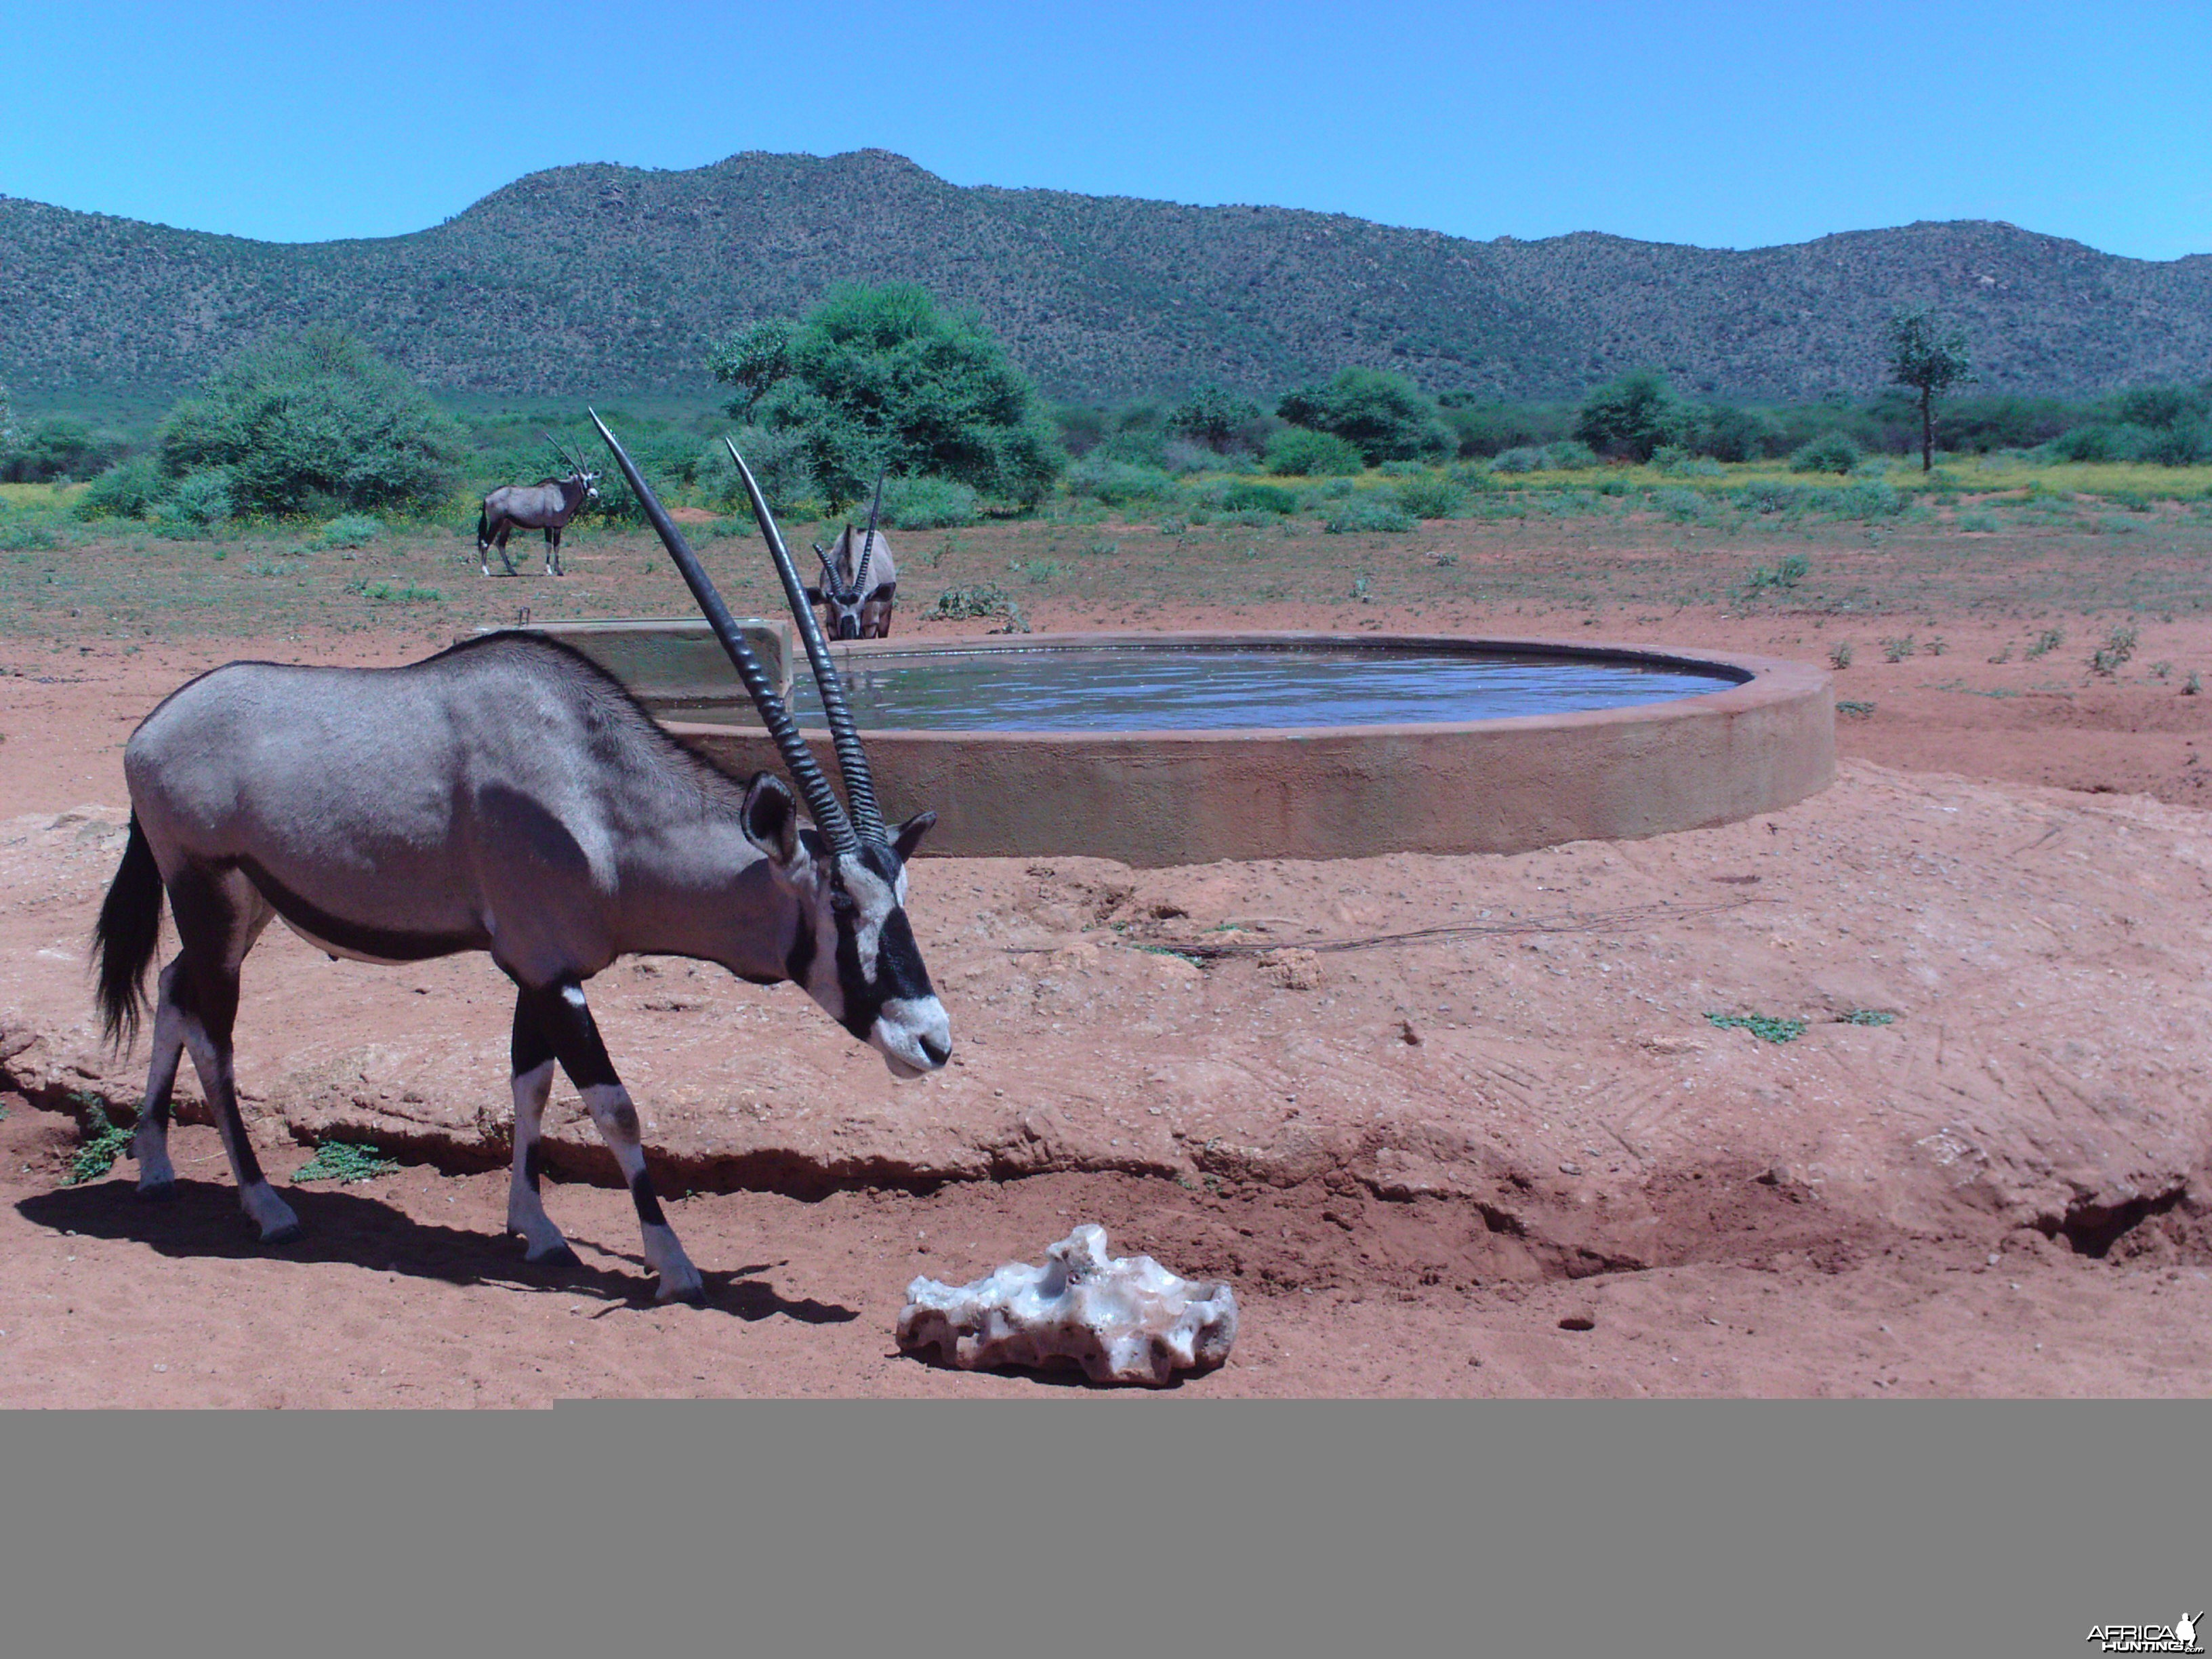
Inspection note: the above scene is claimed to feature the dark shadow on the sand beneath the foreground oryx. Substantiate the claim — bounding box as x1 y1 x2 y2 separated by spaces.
16 1179 861 1325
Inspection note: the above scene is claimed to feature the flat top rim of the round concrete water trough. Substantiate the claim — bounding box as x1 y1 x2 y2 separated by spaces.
661 628 1829 743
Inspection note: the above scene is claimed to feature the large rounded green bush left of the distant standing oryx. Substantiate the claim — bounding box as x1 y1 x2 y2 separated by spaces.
159 327 462 513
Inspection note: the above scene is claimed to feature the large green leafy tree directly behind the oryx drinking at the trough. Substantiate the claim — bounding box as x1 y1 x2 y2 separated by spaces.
734 283 1066 513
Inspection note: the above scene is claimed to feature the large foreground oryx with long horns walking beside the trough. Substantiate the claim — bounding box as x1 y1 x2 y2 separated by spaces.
95 416 951 1298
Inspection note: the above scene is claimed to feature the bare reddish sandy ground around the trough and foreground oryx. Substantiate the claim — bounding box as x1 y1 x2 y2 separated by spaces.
0 526 2212 1405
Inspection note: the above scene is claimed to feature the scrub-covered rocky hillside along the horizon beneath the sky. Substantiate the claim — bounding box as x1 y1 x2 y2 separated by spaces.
0 150 2212 403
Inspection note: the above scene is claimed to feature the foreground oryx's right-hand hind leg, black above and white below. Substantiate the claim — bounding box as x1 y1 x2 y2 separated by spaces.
164 867 299 1243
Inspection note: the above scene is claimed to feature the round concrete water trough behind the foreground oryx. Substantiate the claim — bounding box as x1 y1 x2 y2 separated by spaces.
650 633 1836 867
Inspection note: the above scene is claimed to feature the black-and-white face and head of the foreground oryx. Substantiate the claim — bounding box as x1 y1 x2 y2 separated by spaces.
765 812 954 1078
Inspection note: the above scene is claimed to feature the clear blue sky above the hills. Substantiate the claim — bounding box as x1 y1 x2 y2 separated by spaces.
0 0 2212 259
